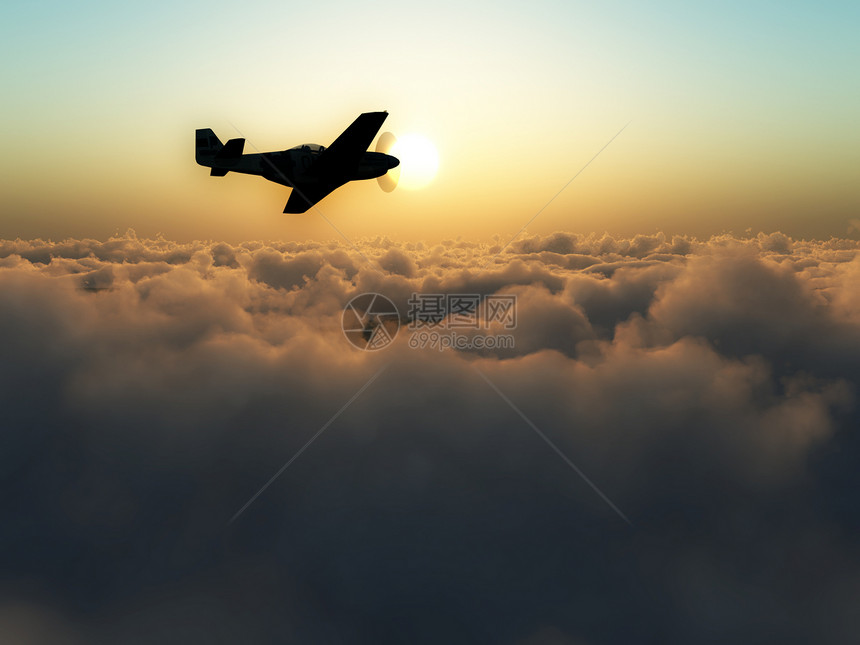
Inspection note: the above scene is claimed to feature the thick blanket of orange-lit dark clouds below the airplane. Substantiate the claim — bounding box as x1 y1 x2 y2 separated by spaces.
0 232 860 643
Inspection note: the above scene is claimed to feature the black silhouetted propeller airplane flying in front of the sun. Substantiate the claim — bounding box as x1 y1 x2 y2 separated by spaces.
195 112 400 213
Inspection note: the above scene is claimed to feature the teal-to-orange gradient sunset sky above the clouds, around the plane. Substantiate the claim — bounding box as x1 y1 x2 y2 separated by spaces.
0 1 860 242
